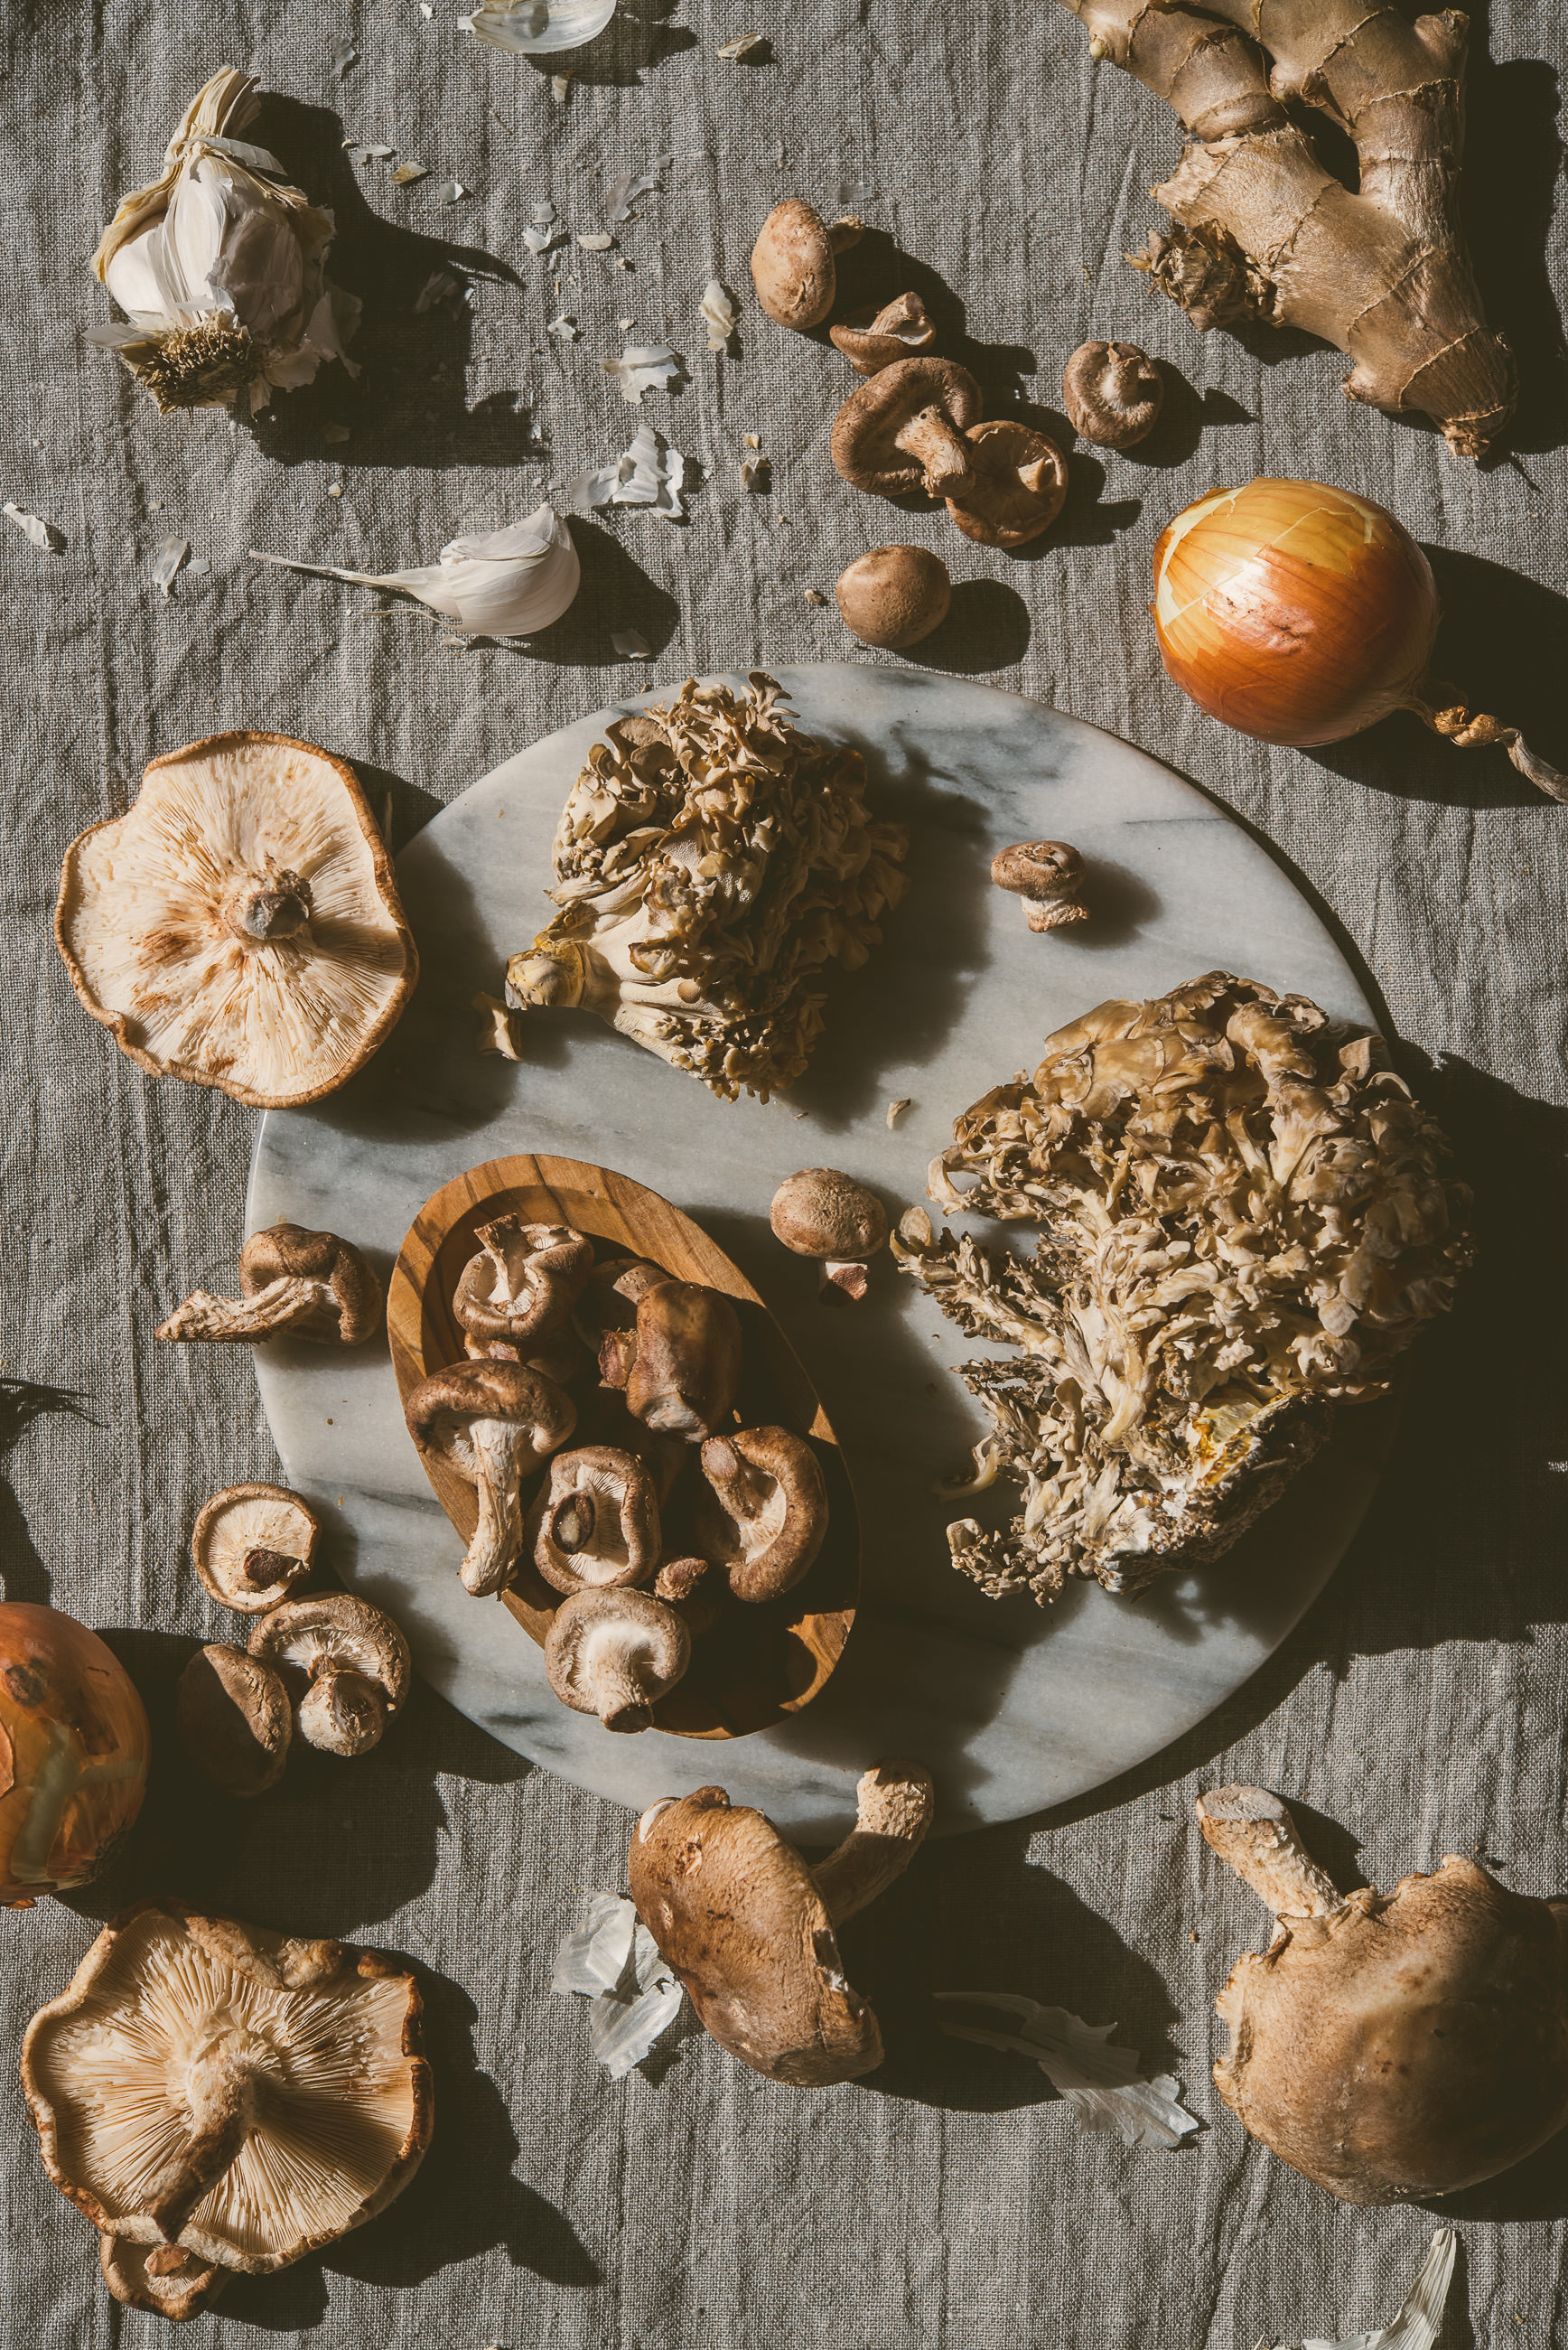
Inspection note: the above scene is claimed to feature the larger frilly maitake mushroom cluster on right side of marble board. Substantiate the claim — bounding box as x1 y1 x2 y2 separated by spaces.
891 970 1471 1603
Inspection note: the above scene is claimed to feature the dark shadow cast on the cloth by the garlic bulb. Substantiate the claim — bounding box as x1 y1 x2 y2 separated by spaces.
249 89 547 472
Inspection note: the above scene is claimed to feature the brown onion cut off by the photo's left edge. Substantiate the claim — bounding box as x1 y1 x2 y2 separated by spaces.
0 1600 153 1908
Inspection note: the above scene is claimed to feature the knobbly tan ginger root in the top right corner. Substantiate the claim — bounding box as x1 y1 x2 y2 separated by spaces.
1062 0 1517 456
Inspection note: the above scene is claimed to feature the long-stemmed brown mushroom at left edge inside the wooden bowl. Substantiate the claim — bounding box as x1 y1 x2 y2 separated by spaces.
402 1361 576 1598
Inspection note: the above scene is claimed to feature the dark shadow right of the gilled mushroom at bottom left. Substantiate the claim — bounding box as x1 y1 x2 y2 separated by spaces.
322 1967 604 2293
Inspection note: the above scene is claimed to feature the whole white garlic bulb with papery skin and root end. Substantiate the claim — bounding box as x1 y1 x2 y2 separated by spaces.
92 66 359 416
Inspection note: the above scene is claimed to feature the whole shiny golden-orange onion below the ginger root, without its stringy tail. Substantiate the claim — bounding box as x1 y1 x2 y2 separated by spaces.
1152 477 1439 747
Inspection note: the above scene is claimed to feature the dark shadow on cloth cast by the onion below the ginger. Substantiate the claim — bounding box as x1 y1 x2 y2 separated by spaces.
1304 545 1568 820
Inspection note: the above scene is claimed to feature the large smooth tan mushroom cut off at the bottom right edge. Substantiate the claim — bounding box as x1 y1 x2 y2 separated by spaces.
1197 1786 1568 2205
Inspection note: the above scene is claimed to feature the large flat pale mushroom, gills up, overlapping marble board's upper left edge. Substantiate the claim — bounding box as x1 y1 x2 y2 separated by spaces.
54 734 418 1109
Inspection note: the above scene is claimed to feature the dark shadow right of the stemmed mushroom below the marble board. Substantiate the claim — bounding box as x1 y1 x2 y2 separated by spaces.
839 1821 1189 2112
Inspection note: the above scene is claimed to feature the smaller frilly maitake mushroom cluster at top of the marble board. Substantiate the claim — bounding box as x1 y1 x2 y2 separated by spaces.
506 669 908 1102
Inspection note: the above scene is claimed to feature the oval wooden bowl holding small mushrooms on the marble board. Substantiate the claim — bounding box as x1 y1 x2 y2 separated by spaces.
386 1156 861 1739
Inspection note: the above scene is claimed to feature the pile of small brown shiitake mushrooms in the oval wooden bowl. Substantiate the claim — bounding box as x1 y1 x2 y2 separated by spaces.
405 1215 827 1729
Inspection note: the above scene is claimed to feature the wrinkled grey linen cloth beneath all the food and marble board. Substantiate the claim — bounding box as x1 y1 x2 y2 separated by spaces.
0 0 1568 2350
